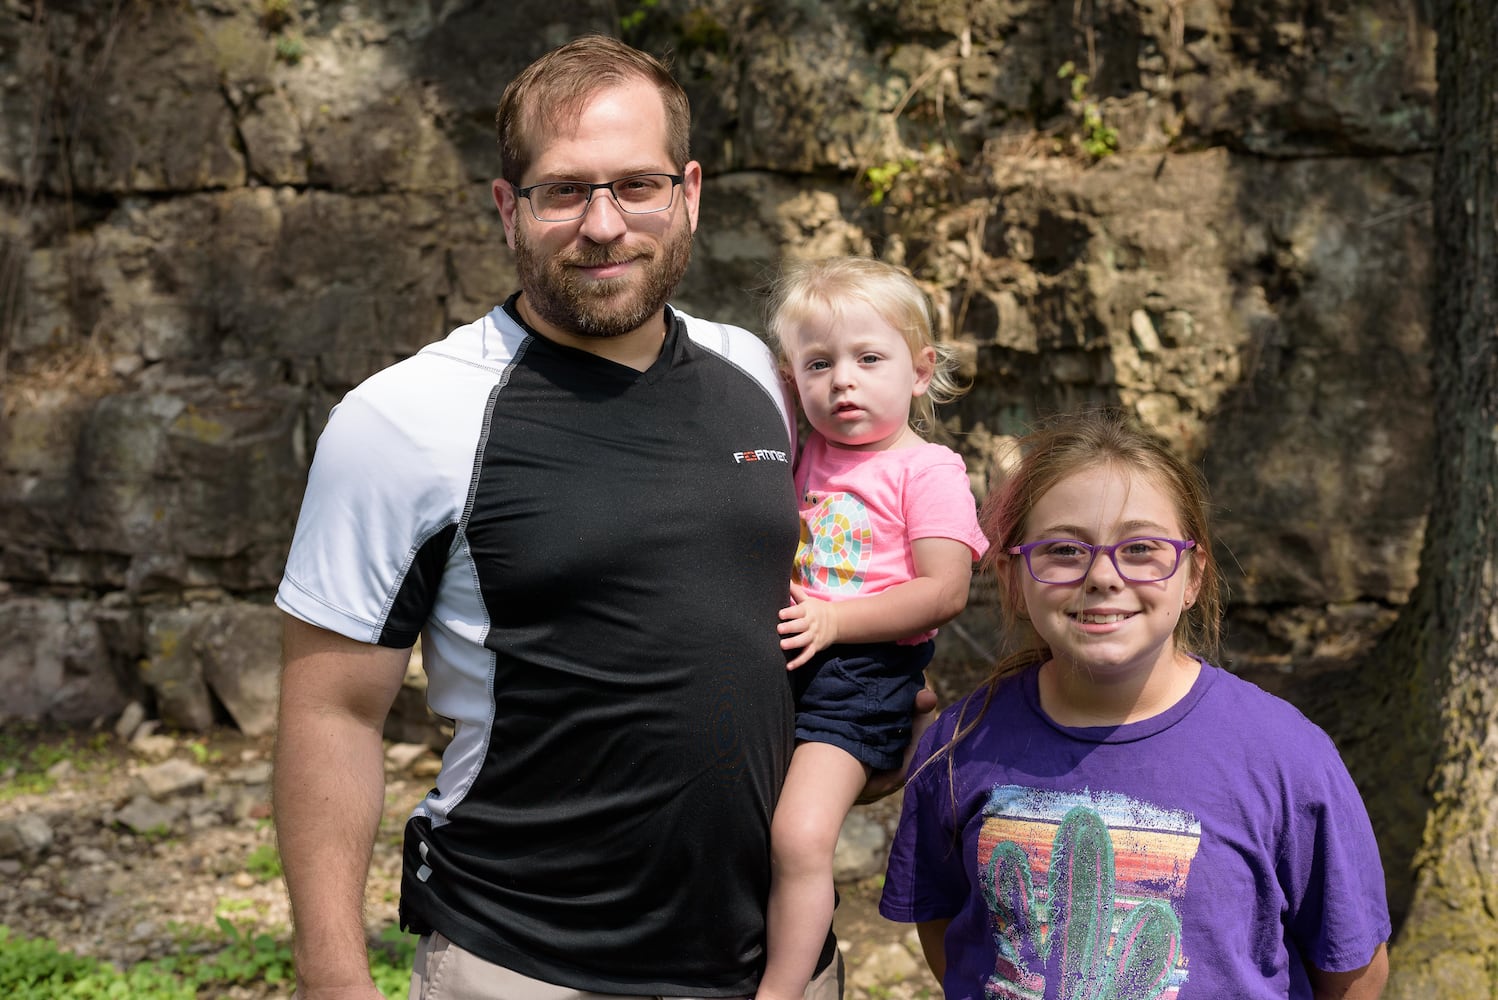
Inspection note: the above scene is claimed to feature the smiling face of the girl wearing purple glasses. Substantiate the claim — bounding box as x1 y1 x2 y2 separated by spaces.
1013 466 1200 681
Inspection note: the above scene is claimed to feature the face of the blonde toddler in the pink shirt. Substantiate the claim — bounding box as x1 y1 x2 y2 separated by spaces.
782 302 936 451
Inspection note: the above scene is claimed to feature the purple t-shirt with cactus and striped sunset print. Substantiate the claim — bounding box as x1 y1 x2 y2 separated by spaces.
879 663 1390 1000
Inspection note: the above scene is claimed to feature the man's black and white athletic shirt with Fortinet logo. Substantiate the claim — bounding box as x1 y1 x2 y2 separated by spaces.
276 298 798 996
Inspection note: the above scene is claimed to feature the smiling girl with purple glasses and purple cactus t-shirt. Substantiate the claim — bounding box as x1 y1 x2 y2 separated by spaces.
879 415 1390 1000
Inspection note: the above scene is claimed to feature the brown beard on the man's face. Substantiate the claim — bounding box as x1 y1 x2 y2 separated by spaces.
515 211 692 338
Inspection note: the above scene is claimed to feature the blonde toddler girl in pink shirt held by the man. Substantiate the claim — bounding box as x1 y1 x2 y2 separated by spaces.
758 257 987 1000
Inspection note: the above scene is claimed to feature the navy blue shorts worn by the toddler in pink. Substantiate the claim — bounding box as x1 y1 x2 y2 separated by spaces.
791 641 936 771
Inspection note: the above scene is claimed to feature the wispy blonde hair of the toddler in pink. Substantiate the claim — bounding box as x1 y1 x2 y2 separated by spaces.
765 256 968 436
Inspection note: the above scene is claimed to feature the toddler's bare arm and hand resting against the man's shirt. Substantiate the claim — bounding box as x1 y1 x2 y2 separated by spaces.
777 537 972 669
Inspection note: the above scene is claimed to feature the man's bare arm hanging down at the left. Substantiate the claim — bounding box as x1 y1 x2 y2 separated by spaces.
273 615 410 1000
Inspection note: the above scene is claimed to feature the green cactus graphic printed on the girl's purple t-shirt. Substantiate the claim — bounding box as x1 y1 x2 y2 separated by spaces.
980 805 1180 1000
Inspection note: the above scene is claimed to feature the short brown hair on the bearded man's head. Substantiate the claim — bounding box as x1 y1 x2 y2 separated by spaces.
494 34 692 186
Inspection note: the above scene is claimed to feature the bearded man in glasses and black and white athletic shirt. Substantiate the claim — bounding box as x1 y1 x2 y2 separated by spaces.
274 36 840 1000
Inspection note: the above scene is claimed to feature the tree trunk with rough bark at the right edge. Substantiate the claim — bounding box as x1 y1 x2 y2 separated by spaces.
1375 0 1498 1000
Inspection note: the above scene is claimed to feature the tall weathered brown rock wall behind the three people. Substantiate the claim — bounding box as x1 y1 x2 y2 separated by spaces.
0 0 1435 732
